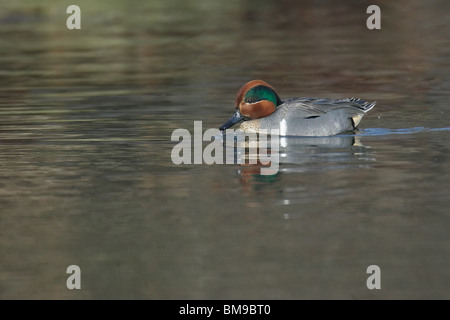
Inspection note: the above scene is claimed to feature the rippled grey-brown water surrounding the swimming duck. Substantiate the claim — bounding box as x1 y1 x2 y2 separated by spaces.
0 0 450 299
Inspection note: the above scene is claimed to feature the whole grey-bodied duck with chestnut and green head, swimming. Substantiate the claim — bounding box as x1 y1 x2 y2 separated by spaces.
219 80 376 137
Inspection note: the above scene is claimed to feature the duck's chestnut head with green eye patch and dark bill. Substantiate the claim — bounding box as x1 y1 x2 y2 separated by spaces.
219 80 281 131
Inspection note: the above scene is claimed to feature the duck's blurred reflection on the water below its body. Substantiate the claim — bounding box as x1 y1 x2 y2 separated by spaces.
227 134 375 189
